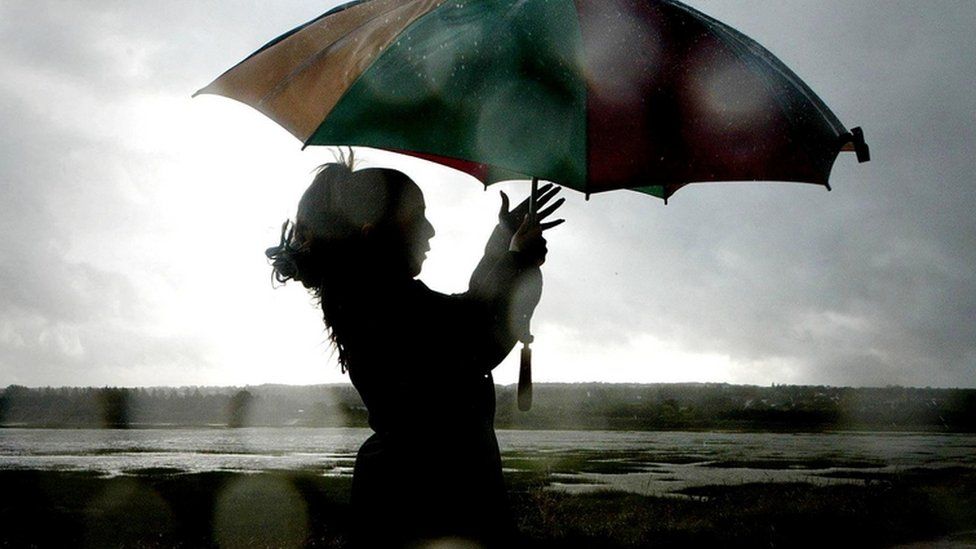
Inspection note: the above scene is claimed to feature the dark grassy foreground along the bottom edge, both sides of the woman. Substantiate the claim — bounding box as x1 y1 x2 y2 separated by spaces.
0 469 976 548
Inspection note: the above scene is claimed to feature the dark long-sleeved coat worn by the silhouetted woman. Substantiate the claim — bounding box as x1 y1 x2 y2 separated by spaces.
346 223 542 547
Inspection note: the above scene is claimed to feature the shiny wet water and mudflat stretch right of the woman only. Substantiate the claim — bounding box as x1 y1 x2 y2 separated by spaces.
499 431 976 494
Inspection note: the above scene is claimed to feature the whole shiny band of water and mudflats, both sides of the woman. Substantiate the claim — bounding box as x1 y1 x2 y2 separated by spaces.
0 428 976 494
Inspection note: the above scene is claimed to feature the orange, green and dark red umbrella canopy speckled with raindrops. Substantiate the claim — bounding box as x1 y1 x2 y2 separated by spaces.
198 0 867 199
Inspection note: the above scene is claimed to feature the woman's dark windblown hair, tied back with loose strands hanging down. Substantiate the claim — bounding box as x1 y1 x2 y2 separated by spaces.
265 151 411 372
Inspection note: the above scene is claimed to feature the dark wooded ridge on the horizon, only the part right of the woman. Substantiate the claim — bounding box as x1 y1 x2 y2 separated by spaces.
496 383 976 432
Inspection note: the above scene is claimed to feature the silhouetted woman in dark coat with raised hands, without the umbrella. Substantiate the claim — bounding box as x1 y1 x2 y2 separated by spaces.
267 156 562 547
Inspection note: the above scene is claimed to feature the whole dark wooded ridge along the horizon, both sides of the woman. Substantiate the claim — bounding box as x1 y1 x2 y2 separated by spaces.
0 383 976 432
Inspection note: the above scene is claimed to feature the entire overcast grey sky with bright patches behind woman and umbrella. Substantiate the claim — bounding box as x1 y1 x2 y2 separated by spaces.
0 0 976 387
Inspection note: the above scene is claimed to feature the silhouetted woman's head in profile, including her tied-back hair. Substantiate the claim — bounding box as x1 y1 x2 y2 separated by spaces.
265 158 434 367
